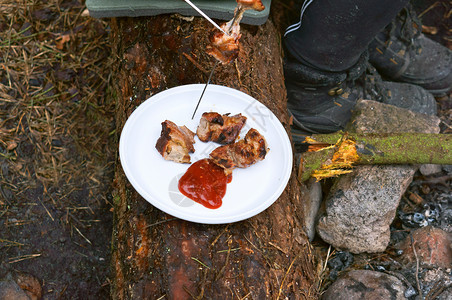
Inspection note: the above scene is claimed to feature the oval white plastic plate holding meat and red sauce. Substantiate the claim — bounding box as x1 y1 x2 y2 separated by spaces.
119 84 292 224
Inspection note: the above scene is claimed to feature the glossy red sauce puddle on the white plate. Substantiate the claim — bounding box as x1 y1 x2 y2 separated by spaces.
179 159 232 209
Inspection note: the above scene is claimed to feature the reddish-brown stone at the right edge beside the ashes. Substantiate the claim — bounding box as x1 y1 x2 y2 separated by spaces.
396 226 452 268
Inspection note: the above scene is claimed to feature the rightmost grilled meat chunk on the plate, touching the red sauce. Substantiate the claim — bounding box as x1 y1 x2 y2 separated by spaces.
210 128 269 173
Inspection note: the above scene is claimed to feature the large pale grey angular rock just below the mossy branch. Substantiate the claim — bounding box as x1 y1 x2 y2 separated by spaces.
317 166 415 254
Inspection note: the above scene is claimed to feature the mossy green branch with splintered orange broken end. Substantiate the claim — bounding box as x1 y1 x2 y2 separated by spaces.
298 132 452 181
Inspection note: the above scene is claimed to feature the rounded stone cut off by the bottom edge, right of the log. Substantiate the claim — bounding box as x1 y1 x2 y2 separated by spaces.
322 270 407 300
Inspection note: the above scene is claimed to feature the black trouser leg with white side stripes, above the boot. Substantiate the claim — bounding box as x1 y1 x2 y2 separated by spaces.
284 0 408 72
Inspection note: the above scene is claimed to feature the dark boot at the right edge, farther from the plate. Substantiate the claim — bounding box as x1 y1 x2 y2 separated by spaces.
369 7 452 95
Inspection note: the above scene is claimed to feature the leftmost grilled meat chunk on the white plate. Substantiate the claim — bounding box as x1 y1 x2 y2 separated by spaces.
155 120 195 163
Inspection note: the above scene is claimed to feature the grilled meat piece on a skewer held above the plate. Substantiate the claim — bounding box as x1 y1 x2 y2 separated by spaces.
207 0 265 64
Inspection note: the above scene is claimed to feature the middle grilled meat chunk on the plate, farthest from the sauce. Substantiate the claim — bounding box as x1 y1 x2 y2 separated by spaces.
196 112 246 144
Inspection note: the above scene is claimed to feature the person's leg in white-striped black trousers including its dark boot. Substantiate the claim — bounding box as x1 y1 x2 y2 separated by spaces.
284 0 436 133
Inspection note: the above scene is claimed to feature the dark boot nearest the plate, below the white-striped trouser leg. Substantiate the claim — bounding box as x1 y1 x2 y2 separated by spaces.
284 55 436 133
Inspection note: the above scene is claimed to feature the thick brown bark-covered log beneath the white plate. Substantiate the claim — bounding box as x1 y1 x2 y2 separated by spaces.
111 8 318 299
